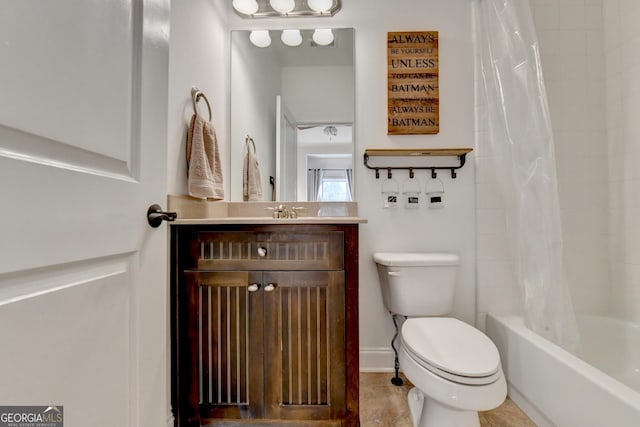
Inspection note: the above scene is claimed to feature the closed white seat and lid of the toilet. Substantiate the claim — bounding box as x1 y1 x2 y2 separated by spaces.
401 317 501 385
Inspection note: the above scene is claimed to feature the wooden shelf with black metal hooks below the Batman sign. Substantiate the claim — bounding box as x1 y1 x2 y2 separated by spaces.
364 148 473 179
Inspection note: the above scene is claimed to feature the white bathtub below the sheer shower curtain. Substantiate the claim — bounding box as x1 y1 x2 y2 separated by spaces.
486 314 640 427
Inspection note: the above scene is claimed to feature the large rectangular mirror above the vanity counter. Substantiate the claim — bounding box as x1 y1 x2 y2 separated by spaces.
228 28 355 201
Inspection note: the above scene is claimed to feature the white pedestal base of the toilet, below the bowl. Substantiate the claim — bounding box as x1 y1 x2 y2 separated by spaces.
407 387 480 427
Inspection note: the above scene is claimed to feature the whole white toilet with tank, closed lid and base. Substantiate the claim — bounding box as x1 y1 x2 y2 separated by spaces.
373 252 507 427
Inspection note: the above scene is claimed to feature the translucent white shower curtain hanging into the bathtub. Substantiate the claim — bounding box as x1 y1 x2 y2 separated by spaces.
473 0 579 352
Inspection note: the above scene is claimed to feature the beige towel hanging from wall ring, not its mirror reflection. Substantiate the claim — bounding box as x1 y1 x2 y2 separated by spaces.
187 114 224 200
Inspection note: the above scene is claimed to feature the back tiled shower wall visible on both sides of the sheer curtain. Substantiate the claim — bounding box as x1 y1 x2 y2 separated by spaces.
476 0 608 328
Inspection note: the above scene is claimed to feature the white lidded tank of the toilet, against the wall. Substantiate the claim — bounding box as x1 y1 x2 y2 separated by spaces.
373 252 460 317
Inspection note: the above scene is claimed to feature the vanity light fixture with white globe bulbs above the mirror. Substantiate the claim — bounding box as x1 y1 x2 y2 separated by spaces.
232 0 341 18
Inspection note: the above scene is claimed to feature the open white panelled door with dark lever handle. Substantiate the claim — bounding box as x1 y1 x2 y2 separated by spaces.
0 0 171 427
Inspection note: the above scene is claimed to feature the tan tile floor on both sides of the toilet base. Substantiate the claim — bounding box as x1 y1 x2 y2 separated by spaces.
360 373 535 427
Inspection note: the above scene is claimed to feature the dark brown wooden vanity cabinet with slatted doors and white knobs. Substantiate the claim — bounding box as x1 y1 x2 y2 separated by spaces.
171 224 359 427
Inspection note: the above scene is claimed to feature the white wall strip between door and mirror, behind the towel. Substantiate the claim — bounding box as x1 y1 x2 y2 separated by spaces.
168 0 229 200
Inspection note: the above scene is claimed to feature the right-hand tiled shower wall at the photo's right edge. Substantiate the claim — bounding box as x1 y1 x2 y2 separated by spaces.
603 0 640 322
